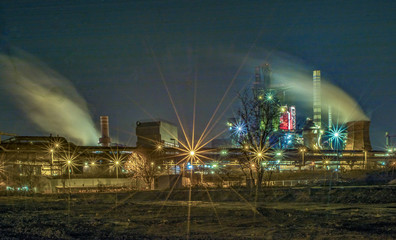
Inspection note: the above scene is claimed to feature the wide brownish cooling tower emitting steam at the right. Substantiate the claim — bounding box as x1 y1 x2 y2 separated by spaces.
345 121 372 151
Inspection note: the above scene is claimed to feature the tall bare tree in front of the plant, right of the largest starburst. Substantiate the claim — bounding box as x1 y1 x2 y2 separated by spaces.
232 90 280 189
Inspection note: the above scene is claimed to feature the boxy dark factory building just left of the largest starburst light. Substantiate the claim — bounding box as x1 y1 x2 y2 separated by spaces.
136 120 179 148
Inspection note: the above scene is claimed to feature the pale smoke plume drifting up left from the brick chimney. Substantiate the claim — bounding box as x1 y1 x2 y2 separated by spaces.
0 53 100 145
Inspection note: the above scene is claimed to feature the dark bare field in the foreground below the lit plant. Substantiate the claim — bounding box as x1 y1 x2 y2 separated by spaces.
0 187 396 239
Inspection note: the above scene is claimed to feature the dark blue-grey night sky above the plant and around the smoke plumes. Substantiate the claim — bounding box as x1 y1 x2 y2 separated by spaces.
0 0 396 149
